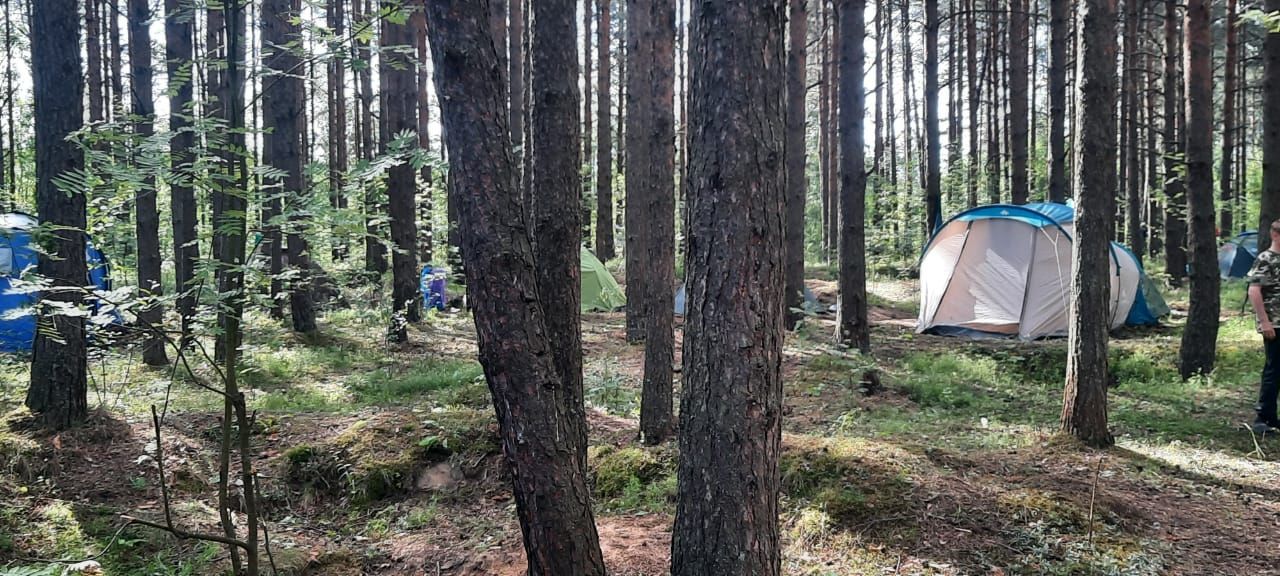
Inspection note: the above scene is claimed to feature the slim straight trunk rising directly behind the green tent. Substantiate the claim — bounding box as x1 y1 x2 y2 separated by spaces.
595 0 617 261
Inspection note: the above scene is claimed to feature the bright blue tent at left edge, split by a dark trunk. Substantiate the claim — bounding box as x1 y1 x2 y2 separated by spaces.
0 212 111 352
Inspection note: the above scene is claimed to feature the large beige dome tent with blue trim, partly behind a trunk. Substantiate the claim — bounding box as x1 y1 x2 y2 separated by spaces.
916 204 1164 339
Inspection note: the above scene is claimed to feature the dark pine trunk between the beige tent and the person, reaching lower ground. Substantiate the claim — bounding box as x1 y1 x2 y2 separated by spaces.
1178 0 1221 379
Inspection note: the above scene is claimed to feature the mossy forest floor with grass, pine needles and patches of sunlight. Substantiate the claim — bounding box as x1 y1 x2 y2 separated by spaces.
0 274 1280 576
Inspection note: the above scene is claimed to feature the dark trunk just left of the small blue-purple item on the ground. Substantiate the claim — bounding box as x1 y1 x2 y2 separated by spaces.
378 3 422 342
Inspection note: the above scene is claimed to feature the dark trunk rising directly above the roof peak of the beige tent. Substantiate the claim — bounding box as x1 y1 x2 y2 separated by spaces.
1007 0 1030 204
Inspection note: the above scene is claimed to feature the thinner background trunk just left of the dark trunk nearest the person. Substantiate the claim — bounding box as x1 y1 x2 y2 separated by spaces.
1161 0 1187 281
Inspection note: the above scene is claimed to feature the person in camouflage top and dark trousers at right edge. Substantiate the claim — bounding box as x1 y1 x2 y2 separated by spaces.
1247 220 1280 434
